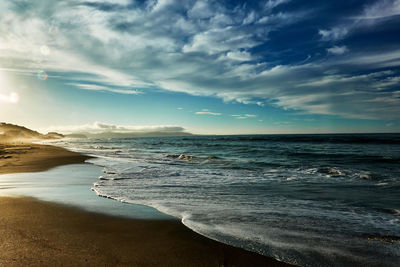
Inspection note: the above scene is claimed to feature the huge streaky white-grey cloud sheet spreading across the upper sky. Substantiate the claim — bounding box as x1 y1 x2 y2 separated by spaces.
0 0 400 119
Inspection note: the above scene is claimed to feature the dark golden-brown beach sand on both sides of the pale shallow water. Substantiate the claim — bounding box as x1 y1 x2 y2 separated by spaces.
0 144 288 266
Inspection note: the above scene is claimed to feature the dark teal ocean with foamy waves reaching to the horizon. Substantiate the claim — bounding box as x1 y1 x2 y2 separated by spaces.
46 134 400 266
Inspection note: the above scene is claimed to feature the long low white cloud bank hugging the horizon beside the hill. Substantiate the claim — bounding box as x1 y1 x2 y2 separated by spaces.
44 122 185 134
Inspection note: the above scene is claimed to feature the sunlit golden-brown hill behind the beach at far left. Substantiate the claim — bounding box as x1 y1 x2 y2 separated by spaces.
0 122 64 142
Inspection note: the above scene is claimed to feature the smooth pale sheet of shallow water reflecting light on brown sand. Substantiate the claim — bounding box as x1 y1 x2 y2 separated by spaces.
0 164 171 219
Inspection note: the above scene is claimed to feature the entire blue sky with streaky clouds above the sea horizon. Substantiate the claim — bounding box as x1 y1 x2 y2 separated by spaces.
0 0 400 134
